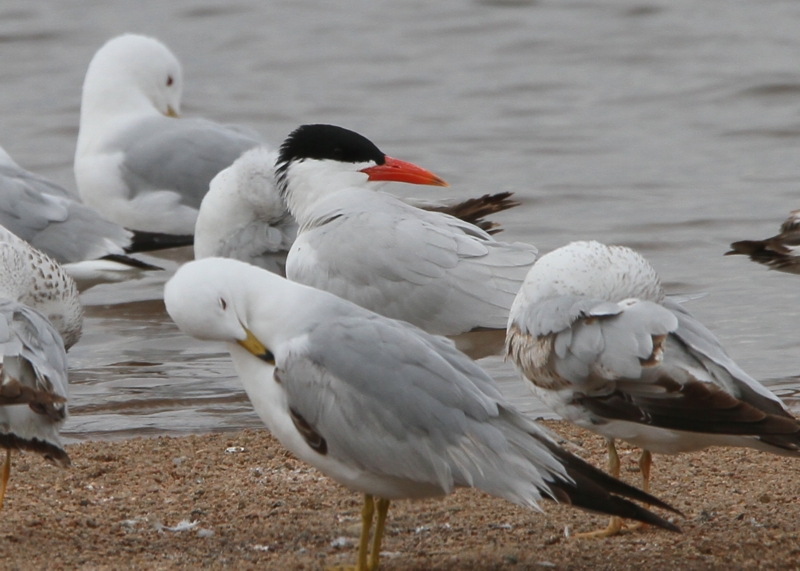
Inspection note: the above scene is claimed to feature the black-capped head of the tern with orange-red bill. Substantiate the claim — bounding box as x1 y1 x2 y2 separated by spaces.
275 125 447 216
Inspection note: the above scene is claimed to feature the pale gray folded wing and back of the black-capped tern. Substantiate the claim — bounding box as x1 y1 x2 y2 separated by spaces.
286 191 537 335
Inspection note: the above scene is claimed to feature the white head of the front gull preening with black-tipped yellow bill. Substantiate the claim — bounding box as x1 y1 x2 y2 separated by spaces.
164 258 248 343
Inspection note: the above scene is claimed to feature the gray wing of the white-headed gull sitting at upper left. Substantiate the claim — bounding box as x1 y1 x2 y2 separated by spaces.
115 116 263 208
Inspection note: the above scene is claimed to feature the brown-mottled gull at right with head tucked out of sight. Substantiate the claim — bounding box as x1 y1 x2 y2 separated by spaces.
506 242 800 535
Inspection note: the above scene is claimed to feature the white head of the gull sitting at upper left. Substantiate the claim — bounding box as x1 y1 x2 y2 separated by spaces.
81 34 183 121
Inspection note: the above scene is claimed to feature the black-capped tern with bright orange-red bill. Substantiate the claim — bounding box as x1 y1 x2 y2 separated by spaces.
276 125 537 357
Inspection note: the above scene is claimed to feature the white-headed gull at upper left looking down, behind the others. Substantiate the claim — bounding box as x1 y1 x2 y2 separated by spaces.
75 34 261 239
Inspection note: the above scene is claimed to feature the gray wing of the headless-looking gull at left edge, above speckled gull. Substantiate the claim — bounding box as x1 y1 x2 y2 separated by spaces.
0 164 131 263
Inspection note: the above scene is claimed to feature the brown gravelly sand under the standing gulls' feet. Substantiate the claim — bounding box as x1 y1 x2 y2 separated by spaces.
0 422 800 571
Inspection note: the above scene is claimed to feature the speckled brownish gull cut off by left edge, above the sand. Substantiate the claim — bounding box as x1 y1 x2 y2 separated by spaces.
0 226 83 507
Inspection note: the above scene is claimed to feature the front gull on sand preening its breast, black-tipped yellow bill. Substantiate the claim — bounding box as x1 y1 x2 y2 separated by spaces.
164 258 677 570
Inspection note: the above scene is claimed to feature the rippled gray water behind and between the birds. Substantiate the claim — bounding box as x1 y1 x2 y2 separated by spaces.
0 0 800 438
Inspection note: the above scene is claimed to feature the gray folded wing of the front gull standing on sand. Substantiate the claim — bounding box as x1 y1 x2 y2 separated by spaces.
276 312 565 503
